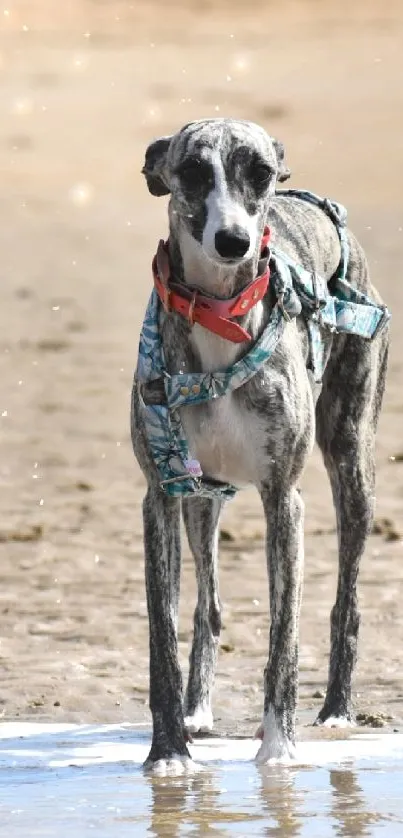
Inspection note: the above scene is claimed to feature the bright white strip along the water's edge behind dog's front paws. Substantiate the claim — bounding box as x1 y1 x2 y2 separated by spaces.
0 722 403 769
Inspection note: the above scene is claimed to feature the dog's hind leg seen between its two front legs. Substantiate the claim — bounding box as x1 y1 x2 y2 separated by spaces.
183 498 223 733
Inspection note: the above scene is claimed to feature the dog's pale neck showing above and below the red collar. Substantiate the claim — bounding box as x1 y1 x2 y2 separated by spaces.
169 220 263 372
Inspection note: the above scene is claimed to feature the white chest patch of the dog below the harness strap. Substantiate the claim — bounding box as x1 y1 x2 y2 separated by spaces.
181 393 265 486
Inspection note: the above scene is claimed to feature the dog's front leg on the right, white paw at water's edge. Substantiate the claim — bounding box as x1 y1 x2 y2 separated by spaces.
256 487 304 763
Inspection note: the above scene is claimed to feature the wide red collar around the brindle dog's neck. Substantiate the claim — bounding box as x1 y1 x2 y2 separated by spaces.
152 227 270 343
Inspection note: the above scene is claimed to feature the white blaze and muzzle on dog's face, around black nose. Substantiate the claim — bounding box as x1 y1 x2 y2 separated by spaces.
202 153 259 262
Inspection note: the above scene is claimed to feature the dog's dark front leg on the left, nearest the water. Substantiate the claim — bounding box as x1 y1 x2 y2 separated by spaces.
143 487 191 773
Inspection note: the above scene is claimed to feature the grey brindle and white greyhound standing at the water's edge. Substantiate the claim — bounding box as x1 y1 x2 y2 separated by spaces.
131 119 388 773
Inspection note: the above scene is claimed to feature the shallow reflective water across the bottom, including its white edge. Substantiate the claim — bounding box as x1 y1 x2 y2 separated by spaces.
0 723 403 838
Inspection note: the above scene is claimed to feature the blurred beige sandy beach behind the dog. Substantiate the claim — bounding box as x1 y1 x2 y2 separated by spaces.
0 0 403 733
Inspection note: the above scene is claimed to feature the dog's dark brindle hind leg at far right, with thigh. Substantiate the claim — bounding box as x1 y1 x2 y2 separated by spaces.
316 334 387 726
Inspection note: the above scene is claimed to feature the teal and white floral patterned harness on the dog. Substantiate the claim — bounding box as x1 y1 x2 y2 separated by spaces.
135 190 390 498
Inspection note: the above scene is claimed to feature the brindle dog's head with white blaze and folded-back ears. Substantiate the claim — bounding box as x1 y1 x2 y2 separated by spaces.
143 119 290 264
